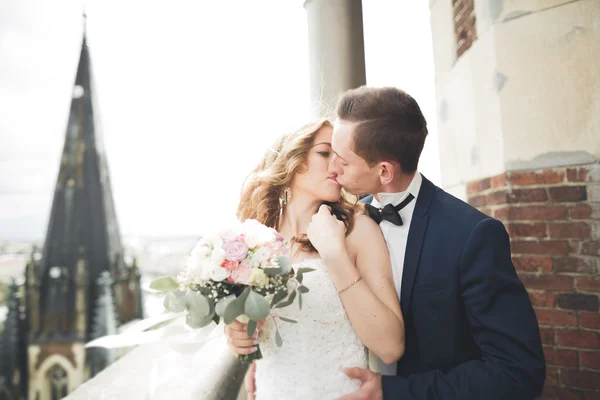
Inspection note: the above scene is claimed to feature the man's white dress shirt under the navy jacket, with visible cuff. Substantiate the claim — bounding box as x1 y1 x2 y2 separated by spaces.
369 172 423 375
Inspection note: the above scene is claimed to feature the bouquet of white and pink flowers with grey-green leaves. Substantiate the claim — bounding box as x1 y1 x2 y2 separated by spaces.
150 220 313 363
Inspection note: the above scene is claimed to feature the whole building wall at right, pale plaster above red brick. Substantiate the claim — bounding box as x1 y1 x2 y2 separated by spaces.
430 0 600 398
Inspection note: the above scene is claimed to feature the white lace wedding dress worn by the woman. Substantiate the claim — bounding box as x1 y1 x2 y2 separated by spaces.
256 259 368 400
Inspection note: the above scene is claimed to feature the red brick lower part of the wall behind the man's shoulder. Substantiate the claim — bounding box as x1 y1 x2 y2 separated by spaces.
467 164 600 400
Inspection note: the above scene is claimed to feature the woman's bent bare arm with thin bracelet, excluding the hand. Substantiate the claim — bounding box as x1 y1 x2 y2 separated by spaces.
321 215 404 364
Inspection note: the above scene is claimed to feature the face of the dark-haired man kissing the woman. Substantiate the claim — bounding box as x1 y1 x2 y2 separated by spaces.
329 119 380 195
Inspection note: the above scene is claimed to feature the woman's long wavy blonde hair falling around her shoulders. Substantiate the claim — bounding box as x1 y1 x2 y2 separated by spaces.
237 119 358 252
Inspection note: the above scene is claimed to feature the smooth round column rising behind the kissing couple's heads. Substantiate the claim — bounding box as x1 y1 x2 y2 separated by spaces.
304 0 366 117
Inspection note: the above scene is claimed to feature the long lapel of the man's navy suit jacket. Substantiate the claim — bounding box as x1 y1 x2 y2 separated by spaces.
400 176 436 318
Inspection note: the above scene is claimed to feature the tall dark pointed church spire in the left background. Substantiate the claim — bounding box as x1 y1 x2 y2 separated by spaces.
40 19 123 340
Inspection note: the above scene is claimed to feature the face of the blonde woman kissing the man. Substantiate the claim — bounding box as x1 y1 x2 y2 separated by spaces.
290 126 342 202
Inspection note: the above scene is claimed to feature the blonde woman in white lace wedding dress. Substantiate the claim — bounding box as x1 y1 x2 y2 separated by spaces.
225 120 404 400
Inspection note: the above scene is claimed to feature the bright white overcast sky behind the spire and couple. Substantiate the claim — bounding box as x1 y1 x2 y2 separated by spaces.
0 0 440 240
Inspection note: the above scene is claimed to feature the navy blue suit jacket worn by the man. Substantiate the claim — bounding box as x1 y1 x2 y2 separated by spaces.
363 177 545 400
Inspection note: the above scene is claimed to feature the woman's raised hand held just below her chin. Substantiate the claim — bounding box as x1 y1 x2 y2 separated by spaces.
306 205 346 257
